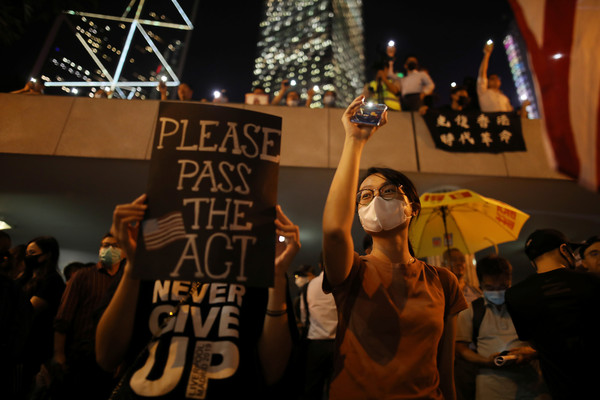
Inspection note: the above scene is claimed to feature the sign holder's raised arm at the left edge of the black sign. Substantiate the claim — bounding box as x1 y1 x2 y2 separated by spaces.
96 194 147 371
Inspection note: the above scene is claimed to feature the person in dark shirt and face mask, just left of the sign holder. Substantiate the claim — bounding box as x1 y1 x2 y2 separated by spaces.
53 233 124 399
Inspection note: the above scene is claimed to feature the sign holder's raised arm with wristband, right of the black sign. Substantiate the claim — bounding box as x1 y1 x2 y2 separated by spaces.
258 206 300 385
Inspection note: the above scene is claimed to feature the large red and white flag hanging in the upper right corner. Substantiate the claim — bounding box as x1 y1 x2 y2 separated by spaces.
510 0 600 191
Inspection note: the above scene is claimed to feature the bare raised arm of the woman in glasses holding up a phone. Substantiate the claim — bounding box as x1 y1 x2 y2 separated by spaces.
323 96 387 286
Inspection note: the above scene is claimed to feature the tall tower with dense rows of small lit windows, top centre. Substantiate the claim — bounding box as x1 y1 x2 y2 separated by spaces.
252 0 364 107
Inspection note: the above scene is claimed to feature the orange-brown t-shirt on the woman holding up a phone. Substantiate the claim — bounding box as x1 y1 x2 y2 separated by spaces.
323 253 467 399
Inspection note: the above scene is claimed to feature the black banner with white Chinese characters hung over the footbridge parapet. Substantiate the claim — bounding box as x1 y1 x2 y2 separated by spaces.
423 110 526 153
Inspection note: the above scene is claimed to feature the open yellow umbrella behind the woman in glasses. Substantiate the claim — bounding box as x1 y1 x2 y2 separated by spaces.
409 189 529 257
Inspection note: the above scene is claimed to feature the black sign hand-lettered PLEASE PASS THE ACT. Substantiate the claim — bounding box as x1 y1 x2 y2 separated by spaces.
133 102 281 287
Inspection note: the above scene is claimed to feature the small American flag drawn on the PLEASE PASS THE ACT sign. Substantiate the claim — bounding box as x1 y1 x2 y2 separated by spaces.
142 211 186 250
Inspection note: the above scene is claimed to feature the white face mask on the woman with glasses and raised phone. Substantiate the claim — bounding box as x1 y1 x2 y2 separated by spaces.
358 196 408 232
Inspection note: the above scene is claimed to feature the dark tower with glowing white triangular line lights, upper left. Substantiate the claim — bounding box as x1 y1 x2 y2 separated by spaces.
33 0 198 99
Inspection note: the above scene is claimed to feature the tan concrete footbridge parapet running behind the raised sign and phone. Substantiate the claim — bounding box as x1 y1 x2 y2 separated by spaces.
0 94 563 179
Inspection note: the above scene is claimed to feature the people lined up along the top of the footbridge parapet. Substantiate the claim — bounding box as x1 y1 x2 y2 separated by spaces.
12 42 530 114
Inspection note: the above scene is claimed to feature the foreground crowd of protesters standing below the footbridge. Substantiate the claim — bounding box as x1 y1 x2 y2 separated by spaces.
0 94 600 399
